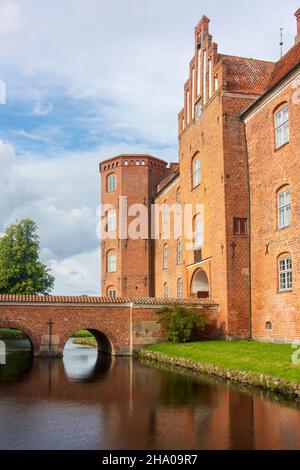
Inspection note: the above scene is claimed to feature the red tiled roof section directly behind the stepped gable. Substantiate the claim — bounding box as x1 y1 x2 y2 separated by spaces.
220 55 275 95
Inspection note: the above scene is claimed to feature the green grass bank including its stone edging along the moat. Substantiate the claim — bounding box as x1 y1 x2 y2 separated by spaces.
141 341 300 397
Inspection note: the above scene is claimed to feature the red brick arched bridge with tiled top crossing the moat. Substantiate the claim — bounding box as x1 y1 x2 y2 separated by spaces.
0 295 218 357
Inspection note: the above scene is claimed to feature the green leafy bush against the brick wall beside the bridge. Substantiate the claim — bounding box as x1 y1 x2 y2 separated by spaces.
158 305 207 343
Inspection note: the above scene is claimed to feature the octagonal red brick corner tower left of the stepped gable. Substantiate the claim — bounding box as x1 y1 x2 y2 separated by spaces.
100 155 167 297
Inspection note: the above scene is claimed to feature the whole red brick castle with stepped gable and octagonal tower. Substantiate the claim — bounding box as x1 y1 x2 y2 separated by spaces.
100 9 300 341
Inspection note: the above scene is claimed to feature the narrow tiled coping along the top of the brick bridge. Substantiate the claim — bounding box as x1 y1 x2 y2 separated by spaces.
0 294 217 306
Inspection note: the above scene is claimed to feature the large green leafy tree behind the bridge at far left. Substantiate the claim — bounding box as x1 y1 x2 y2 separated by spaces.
0 219 54 294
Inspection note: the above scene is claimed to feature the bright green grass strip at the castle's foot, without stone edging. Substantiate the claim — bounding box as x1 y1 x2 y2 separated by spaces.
146 341 300 382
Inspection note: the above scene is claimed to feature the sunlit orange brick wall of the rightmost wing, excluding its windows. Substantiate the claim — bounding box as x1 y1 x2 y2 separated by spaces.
246 73 300 341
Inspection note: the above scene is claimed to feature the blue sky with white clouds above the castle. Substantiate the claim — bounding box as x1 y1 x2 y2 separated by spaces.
0 0 299 294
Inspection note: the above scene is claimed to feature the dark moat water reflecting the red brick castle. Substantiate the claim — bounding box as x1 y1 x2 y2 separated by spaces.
0 340 300 450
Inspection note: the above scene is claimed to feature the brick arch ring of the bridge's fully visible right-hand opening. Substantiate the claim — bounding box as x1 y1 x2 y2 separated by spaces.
59 322 118 356
